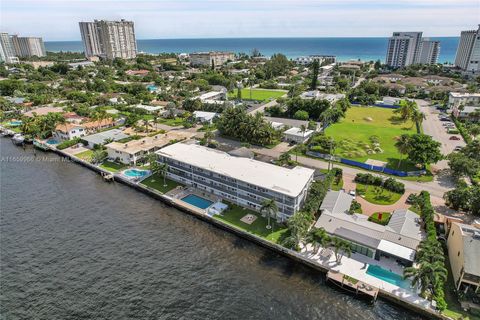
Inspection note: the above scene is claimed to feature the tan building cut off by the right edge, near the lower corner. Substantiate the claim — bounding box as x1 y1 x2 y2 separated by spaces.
447 222 480 293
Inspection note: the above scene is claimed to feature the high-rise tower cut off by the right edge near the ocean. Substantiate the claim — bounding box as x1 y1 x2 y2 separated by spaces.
455 25 480 73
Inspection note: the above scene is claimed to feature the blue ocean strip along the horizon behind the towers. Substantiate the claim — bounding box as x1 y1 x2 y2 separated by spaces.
45 37 459 63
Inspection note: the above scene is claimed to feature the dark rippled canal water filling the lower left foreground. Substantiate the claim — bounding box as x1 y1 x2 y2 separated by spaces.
0 138 420 320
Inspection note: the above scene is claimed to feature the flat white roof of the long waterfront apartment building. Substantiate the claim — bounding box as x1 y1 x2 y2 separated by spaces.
156 143 314 197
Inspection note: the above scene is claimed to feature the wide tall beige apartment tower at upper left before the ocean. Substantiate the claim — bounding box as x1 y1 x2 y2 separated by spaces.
79 19 137 60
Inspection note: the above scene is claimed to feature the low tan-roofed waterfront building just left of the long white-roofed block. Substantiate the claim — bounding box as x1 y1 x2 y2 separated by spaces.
105 131 194 165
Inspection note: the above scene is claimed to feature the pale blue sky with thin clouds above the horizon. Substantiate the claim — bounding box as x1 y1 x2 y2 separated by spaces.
0 0 480 41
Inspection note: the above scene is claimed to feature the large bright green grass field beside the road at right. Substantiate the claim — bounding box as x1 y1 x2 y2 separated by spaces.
325 107 417 171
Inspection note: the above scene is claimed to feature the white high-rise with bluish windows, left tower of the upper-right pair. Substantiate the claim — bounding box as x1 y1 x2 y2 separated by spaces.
385 32 422 68
